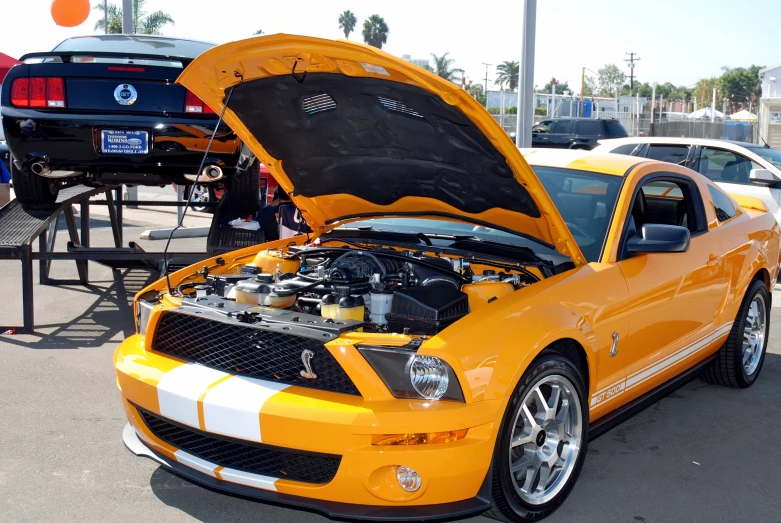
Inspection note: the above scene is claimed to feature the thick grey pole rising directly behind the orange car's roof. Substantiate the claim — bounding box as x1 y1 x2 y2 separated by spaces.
515 0 537 147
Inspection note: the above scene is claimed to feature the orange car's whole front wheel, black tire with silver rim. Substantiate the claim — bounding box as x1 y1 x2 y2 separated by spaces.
486 351 588 523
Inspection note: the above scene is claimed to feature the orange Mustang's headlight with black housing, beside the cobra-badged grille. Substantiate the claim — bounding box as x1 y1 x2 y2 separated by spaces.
358 346 464 401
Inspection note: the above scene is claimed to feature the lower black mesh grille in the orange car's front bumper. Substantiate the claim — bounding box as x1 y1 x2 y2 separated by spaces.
136 407 342 484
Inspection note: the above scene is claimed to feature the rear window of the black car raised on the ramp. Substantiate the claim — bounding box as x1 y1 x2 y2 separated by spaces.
53 35 214 58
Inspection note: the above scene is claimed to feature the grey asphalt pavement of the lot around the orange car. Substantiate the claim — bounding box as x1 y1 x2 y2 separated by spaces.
0 210 781 523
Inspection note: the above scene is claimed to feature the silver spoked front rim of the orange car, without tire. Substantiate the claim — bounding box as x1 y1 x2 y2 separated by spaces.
509 375 584 505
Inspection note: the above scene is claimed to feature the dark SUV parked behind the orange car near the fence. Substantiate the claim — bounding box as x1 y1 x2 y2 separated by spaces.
532 118 628 149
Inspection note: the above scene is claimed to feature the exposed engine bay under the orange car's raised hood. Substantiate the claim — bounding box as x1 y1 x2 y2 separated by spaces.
177 244 544 335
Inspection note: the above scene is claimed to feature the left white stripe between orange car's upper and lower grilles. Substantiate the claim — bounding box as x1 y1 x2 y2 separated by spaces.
157 363 227 428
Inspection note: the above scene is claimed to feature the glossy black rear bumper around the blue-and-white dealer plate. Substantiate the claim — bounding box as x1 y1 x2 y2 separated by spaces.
2 107 241 183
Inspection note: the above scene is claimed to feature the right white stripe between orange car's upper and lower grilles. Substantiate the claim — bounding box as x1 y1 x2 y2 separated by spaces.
203 376 290 441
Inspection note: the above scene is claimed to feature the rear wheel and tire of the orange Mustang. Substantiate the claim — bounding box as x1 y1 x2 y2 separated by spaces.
702 280 770 389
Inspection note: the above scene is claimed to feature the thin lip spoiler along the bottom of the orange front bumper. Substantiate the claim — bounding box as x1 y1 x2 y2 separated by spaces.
122 423 491 521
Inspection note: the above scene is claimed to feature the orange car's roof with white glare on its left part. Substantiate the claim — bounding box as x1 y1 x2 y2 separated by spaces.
521 149 653 176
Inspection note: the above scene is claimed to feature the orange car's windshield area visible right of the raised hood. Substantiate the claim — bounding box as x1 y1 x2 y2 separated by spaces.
532 166 623 262
